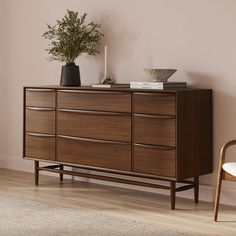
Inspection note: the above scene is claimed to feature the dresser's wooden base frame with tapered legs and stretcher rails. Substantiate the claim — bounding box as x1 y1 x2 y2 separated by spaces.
34 160 199 210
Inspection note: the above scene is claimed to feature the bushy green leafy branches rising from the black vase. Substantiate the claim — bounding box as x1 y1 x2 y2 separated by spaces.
43 10 104 63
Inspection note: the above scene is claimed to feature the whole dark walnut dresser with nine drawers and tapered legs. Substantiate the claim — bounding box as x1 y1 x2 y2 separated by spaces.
23 86 212 209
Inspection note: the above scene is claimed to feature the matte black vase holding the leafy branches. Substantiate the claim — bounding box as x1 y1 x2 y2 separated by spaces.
60 62 81 86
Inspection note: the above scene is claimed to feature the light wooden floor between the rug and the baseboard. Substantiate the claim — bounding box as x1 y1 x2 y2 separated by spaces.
0 169 236 236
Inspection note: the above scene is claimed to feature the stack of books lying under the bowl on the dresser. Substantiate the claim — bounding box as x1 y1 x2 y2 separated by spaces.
130 81 187 89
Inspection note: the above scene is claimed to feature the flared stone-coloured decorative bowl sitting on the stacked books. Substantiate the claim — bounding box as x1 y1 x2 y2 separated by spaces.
144 68 177 82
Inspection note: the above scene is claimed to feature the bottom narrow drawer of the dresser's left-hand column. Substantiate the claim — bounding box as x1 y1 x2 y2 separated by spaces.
25 133 55 160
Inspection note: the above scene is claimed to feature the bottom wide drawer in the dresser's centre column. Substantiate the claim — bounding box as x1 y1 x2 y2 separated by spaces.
57 136 131 171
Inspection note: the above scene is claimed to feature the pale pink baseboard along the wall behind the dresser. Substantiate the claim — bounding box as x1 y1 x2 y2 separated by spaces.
0 155 236 206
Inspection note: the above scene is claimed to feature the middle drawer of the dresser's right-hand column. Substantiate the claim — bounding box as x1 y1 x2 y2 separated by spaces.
134 114 175 146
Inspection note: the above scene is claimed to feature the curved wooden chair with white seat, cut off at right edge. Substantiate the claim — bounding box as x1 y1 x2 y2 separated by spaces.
214 139 236 221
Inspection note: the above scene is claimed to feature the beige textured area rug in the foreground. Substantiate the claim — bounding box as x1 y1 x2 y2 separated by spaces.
0 196 195 236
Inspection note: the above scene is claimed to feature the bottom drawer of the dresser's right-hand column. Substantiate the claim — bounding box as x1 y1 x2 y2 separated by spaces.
133 145 176 177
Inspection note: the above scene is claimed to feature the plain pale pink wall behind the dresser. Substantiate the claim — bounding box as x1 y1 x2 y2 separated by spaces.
0 0 236 205
